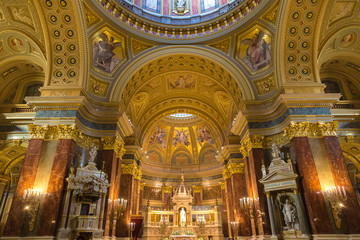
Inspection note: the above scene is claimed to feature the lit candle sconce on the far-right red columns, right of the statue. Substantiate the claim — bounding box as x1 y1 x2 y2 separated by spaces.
322 186 347 229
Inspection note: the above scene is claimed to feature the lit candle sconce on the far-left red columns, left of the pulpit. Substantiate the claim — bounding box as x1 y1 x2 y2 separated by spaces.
23 188 43 232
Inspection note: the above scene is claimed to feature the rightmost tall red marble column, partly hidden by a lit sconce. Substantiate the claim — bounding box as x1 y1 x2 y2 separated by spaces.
324 136 360 234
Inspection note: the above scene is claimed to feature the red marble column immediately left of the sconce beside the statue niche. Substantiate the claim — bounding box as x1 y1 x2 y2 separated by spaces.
231 173 251 236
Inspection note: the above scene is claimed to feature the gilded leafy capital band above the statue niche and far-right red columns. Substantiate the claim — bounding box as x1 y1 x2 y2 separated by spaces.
284 121 339 139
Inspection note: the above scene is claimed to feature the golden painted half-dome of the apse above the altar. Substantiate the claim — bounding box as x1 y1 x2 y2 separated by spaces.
143 120 217 166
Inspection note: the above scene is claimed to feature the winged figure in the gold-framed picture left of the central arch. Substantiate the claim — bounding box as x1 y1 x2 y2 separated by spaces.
93 33 122 72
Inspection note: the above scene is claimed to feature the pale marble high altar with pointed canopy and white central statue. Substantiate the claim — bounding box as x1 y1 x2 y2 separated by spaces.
143 175 224 240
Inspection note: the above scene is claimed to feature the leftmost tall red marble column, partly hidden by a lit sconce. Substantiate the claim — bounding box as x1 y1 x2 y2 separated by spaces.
4 139 44 236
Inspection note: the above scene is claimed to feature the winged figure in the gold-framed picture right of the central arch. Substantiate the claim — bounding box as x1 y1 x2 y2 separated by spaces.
241 30 271 71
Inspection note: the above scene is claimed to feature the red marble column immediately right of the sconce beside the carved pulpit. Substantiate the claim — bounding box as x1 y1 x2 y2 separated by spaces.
115 174 134 237
